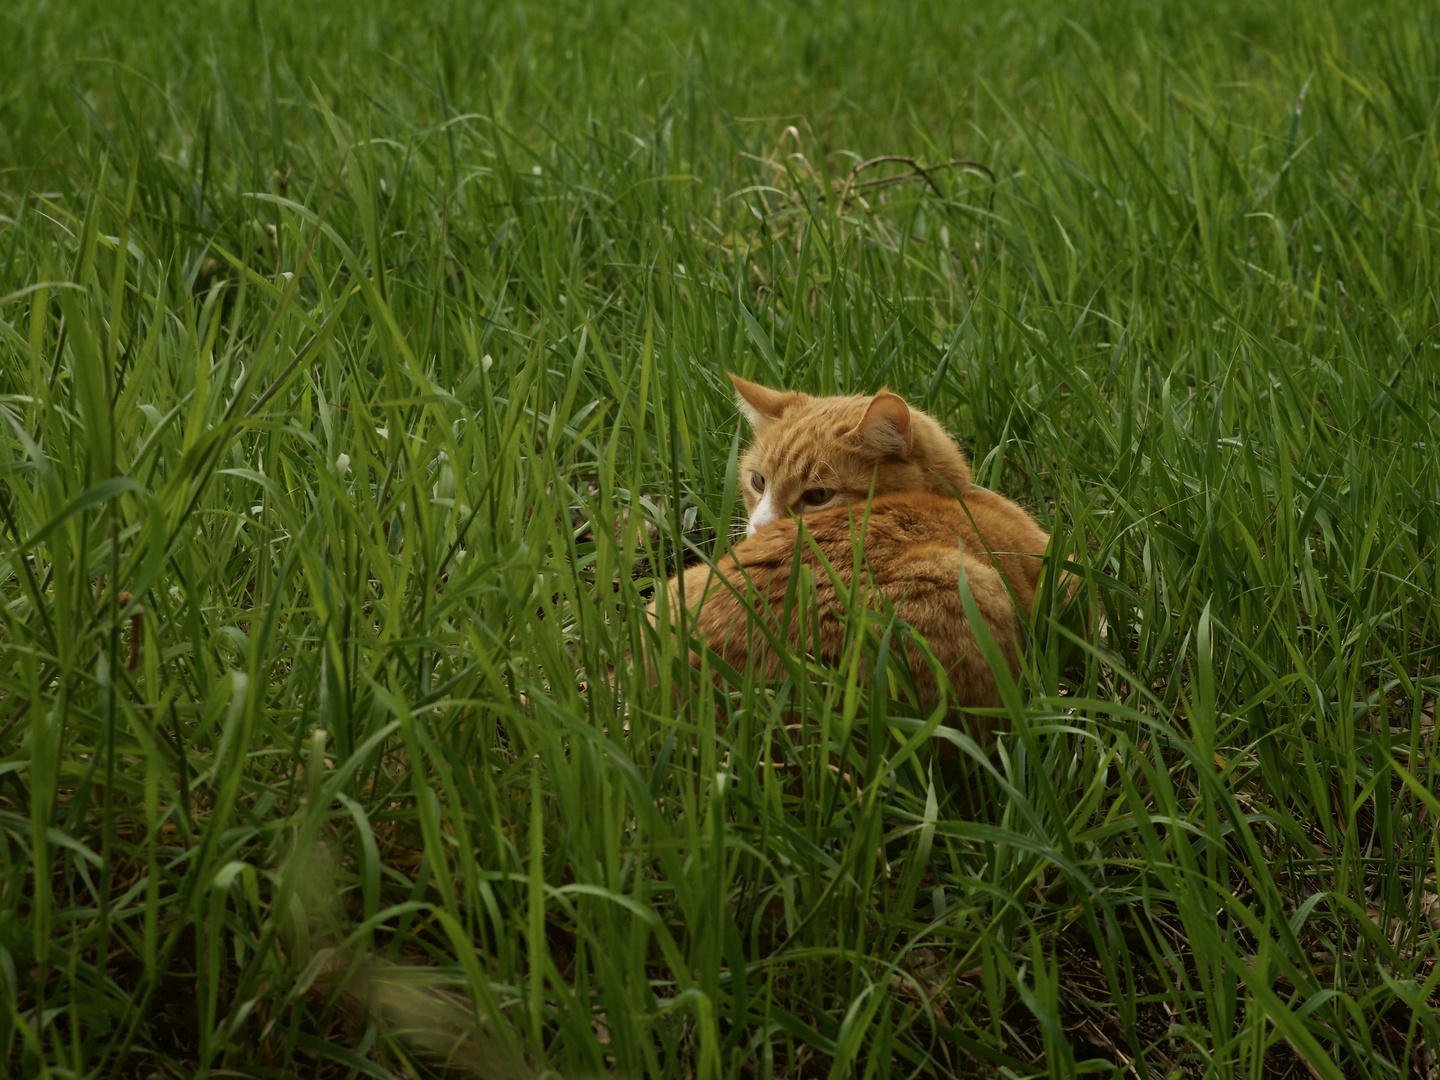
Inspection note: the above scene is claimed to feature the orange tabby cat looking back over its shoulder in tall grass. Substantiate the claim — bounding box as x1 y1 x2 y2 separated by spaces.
651 376 1050 736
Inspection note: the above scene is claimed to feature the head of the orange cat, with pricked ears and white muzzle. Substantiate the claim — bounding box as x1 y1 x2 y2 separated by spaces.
730 374 971 536
